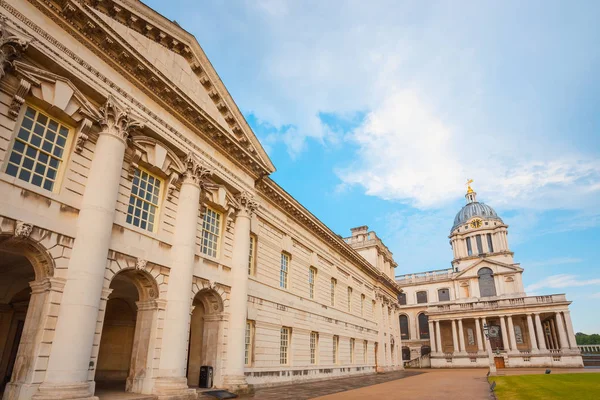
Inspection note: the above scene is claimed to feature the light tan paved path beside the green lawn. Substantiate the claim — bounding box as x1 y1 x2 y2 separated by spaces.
315 369 493 400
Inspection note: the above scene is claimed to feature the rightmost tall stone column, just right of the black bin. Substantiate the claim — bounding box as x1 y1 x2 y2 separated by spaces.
223 192 257 392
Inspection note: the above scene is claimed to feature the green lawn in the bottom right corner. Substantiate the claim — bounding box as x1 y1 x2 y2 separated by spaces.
490 373 600 400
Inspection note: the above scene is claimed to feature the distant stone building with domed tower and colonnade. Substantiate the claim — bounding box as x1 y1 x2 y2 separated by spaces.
396 181 583 368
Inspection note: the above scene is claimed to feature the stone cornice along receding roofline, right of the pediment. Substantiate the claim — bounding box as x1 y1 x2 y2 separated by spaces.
256 177 400 293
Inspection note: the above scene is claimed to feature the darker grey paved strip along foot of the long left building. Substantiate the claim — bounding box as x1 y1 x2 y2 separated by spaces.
240 370 420 400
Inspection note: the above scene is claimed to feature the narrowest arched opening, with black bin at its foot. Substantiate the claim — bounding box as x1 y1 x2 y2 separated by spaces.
187 290 223 387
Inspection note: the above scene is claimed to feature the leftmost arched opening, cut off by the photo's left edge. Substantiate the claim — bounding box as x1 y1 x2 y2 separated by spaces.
0 236 54 398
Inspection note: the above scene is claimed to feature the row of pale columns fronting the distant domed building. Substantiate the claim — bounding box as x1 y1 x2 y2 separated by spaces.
429 311 578 355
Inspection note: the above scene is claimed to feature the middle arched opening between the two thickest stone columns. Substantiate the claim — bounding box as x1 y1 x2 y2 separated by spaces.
95 269 158 393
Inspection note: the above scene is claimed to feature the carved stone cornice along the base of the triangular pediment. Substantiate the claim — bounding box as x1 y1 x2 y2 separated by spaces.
29 0 274 178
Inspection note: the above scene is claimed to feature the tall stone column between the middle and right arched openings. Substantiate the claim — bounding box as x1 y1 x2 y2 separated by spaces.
153 153 211 397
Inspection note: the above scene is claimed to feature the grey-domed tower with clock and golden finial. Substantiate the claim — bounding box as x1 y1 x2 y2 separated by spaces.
449 180 514 271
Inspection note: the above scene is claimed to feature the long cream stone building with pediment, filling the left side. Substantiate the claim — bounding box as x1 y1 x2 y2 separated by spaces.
0 0 401 400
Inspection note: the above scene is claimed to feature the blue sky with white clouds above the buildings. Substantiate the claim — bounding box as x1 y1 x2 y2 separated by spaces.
145 0 600 333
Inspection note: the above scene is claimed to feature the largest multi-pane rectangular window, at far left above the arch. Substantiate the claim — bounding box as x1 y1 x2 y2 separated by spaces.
6 107 69 191
